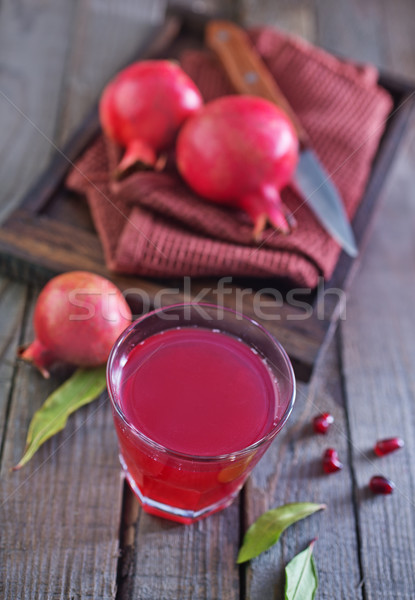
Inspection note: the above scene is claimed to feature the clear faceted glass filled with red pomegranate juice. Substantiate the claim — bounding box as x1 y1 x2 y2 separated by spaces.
107 304 295 523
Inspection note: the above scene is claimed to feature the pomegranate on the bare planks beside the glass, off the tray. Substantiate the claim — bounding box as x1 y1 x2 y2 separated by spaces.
19 271 132 377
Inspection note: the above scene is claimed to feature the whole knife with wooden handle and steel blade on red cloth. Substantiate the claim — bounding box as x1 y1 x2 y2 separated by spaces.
205 20 358 257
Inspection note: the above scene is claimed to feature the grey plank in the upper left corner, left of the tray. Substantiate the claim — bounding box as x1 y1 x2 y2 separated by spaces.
0 0 79 220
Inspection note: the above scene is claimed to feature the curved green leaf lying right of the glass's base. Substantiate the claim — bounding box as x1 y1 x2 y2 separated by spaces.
237 502 326 563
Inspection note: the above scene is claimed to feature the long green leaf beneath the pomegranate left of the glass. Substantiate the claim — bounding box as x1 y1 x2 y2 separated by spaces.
13 365 106 470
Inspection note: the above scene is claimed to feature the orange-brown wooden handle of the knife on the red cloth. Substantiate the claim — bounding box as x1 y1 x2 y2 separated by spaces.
205 20 308 146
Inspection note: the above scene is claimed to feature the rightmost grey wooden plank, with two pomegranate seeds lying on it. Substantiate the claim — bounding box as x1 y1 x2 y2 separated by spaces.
319 0 415 600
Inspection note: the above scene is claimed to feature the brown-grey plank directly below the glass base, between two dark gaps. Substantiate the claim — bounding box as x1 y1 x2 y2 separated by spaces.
119 501 240 600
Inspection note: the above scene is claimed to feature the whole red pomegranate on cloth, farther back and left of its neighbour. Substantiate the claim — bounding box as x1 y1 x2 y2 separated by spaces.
99 60 203 176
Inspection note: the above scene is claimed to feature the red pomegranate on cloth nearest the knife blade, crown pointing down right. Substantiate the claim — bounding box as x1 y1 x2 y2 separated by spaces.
176 95 298 238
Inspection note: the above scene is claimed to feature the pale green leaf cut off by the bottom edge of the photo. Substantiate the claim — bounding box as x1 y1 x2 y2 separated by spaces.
285 541 318 600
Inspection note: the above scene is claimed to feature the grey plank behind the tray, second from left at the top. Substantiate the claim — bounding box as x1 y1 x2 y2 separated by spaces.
58 0 167 142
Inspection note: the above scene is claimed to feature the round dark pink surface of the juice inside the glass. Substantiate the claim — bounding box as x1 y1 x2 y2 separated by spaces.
120 327 278 456
